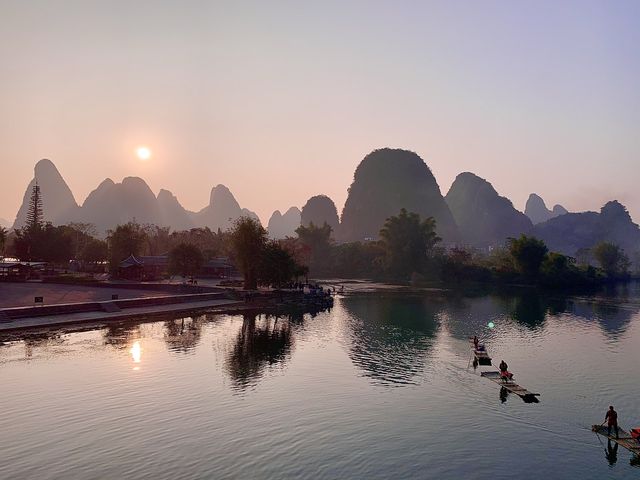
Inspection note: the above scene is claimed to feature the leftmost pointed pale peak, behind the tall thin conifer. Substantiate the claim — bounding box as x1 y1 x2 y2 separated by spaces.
13 158 78 228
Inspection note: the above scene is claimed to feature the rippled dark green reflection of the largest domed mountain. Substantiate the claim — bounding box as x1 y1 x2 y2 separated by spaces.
341 294 440 385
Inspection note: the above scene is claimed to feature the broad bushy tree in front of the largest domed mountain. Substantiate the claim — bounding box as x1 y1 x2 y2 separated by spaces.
380 208 441 276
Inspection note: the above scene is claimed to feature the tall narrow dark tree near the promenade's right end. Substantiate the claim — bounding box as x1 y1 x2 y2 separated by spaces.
231 217 267 290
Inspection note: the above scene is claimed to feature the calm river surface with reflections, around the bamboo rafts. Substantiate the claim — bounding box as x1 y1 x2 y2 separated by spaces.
0 285 640 480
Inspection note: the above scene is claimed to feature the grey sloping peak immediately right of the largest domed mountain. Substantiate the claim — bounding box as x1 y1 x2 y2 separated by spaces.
445 172 533 247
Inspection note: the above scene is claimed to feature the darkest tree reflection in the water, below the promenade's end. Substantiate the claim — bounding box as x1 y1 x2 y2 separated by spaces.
225 314 293 390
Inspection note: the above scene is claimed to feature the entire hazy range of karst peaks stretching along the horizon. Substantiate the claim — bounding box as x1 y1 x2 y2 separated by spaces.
14 148 640 255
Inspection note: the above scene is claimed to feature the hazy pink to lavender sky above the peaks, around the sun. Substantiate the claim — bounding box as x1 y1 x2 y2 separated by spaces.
0 0 640 222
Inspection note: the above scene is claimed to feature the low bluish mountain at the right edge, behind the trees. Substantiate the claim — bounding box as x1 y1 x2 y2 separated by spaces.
533 200 640 256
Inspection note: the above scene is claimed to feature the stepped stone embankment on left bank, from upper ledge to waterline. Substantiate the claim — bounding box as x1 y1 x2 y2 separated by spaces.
0 291 244 331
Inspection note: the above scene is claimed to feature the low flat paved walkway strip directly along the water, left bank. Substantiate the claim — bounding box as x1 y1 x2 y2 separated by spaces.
0 297 243 332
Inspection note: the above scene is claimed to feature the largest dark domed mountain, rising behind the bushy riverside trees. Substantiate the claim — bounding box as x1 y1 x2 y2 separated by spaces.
340 148 458 241
